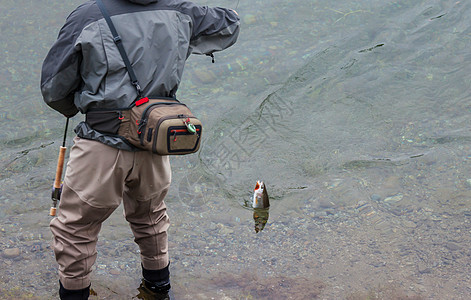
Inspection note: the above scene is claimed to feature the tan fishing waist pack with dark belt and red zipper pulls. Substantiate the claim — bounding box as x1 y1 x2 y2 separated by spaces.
86 97 203 155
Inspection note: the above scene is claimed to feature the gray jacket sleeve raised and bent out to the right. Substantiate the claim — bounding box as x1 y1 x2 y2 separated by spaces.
190 6 240 54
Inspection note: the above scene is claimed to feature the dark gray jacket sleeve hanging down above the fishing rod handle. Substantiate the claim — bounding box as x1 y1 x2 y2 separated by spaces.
41 8 82 116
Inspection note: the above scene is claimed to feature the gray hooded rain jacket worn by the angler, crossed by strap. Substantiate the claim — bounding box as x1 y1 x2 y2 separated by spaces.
41 0 240 150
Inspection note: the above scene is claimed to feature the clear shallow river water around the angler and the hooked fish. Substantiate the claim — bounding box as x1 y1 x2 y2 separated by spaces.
0 0 471 299
